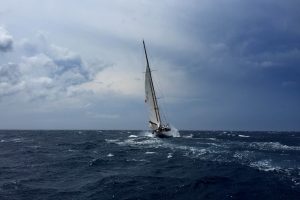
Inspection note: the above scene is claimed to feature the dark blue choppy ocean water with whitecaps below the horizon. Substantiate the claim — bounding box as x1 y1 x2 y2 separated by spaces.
0 130 300 200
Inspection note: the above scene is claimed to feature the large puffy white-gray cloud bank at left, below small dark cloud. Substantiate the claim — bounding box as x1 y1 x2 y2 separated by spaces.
0 34 101 101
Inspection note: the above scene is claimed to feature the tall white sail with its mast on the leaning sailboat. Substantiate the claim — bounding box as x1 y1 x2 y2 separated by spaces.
143 41 161 130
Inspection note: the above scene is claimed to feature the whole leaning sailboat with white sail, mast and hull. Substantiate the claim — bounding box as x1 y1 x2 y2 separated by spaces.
143 40 171 137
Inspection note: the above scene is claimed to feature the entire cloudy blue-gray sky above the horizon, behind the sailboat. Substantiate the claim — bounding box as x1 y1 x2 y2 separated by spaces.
0 0 300 131
